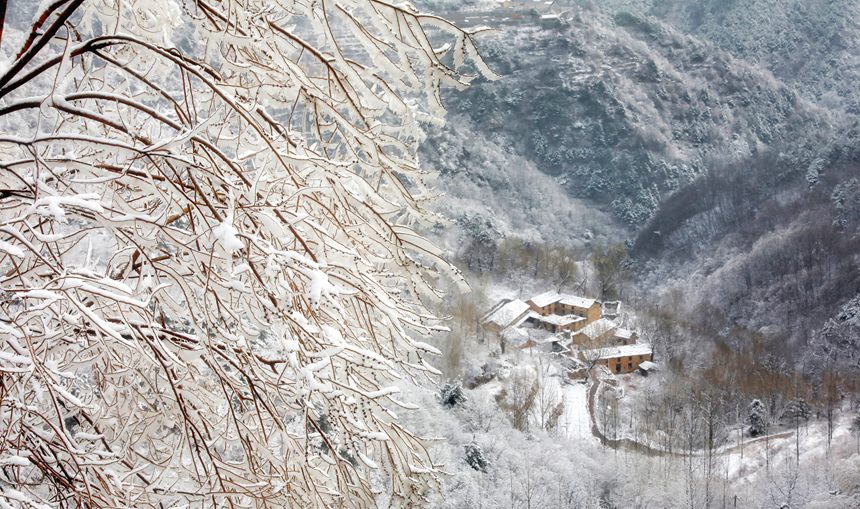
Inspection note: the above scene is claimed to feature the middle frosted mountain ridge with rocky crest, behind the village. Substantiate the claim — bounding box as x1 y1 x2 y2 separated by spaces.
436 5 829 226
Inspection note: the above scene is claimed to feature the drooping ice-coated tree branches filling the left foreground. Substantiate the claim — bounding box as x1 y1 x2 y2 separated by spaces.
0 0 492 507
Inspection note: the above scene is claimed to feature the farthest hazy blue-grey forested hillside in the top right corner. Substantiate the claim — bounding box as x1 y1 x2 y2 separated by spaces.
599 0 860 110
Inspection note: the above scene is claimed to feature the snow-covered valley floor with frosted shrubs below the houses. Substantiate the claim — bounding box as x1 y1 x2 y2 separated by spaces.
416 336 860 509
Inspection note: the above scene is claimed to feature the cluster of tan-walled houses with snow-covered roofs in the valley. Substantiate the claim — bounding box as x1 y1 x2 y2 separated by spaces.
482 291 654 374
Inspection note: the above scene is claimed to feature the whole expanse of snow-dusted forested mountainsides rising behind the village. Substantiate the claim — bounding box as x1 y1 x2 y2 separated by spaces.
424 2 860 378
